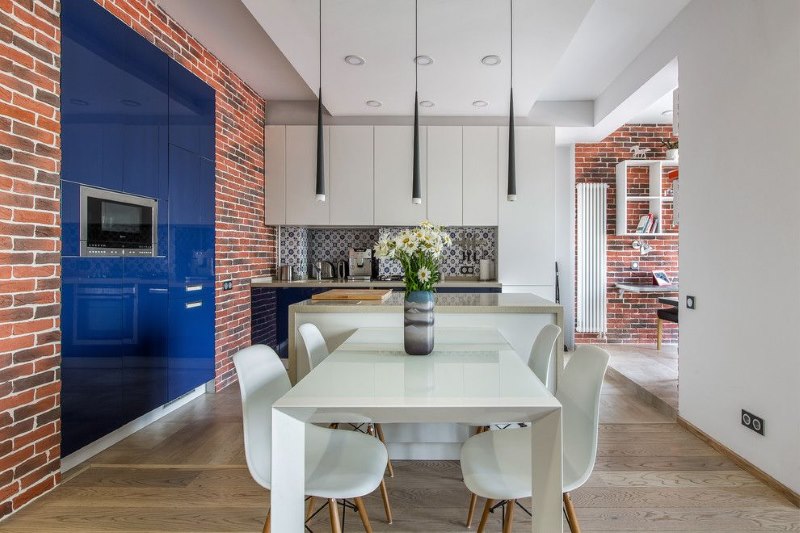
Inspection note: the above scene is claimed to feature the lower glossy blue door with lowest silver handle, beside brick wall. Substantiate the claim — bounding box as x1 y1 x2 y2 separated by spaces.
167 286 214 400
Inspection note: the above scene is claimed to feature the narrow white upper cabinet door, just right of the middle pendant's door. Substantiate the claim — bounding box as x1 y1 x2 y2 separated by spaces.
427 126 462 226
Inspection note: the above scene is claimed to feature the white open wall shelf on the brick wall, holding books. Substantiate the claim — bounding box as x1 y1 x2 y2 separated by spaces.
616 159 678 237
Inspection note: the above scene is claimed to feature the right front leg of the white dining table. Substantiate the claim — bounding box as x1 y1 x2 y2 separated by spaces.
531 409 563 533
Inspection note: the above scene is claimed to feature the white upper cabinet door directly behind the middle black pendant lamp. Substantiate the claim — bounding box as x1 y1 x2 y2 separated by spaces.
375 126 428 226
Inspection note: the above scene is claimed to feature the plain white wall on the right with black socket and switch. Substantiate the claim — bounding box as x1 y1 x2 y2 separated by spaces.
673 0 800 491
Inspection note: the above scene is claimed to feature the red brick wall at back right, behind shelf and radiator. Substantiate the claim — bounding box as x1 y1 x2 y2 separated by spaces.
575 124 678 344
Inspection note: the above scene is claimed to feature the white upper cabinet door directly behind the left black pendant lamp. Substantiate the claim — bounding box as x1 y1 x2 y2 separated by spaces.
286 126 331 226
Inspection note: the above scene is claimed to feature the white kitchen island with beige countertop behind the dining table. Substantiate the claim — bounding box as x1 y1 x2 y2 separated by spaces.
288 292 564 459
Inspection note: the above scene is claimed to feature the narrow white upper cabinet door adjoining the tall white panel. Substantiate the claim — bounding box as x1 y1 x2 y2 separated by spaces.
462 126 499 226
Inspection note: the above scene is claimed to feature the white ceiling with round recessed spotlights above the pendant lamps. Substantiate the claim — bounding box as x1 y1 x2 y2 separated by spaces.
157 0 690 126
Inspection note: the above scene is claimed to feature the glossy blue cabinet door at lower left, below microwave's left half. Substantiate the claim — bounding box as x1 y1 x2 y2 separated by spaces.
61 257 123 455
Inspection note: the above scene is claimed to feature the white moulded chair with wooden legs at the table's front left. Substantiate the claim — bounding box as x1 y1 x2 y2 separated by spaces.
233 345 389 533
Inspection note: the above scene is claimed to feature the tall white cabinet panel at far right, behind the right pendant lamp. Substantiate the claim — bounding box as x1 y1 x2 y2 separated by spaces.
497 126 556 290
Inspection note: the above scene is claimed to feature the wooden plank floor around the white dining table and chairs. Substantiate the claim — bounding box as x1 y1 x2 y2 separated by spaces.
0 376 800 533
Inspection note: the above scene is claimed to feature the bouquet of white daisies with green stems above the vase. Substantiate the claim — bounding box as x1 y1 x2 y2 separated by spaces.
375 220 452 292
